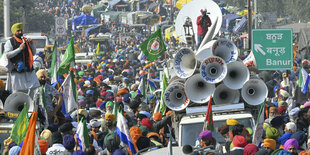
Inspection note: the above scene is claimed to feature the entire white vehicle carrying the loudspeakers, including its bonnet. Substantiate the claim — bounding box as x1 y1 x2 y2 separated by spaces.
142 103 255 155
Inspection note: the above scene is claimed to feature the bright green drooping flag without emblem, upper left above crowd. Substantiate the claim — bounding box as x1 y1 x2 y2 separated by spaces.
58 37 75 75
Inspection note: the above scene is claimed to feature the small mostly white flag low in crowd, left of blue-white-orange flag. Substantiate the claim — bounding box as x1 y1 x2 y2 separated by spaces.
76 117 89 152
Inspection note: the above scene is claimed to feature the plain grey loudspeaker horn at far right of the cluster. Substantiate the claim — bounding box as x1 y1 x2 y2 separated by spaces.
241 79 268 105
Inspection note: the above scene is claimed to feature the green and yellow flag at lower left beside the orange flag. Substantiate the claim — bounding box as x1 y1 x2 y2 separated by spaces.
11 106 29 145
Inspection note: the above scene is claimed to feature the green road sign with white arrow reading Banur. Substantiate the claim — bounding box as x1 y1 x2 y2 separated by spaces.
251 29 293 70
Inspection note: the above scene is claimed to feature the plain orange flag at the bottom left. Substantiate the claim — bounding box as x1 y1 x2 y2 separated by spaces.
20 112 38 155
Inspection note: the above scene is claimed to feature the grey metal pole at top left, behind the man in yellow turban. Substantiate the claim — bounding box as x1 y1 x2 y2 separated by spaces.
3 0 10 38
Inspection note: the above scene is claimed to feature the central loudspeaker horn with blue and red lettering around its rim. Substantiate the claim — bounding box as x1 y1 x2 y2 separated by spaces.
200 56 227 83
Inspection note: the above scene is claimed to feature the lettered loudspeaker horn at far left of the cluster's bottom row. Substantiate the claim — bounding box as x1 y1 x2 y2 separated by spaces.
164 83 190 111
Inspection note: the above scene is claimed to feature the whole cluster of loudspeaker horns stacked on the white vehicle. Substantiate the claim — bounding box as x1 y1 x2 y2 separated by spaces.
164 39 268 111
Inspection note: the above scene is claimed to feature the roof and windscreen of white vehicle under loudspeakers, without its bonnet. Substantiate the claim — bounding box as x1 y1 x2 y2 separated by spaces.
178 103 255 146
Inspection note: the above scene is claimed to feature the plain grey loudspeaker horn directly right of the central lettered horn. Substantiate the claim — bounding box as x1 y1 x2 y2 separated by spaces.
223 61 250 89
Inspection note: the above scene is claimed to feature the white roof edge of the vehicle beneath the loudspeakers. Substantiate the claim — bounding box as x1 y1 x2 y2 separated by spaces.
180 111 253 124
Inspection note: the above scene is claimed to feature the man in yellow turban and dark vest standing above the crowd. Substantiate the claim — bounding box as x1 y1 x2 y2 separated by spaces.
4 23 40 97
